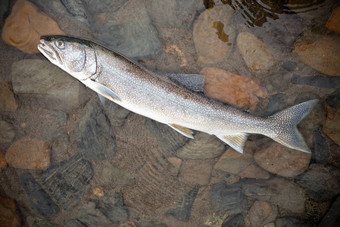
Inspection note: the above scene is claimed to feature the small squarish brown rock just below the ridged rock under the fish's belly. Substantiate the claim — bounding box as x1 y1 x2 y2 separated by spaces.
178 160 213 185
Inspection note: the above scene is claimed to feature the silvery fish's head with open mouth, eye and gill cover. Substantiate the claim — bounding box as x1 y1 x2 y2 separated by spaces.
38 35 98 80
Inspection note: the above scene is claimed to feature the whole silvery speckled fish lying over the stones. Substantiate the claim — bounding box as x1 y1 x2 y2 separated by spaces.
38 35 318 153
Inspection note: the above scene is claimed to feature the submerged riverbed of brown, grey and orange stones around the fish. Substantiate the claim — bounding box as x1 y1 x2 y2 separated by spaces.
0 0 340 227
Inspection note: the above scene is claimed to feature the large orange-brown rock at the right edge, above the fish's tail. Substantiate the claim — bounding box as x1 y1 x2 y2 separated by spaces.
294 35 340 76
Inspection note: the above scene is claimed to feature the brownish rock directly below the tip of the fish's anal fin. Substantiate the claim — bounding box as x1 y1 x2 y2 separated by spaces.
214 148 254 174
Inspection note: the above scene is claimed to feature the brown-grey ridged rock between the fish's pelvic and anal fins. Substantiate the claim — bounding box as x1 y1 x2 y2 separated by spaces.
176 133 224 159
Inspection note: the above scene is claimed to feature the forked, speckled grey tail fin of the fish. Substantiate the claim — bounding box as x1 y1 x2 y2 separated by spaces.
268 99 318 153
